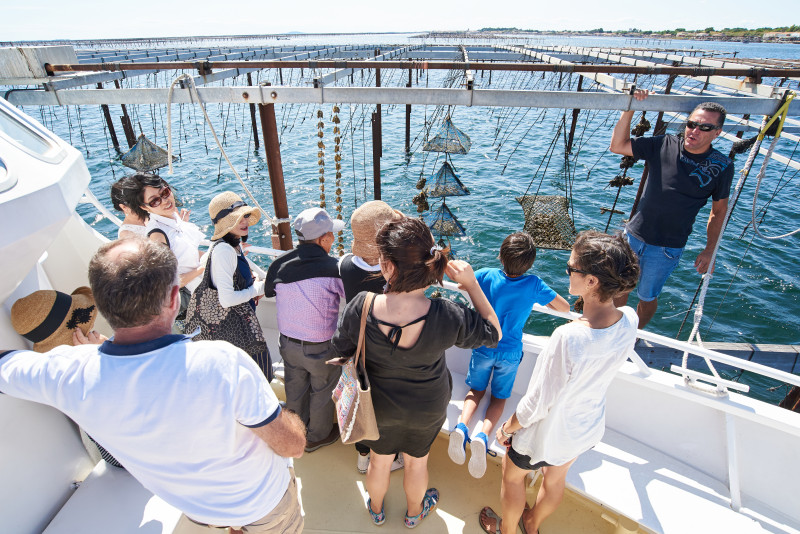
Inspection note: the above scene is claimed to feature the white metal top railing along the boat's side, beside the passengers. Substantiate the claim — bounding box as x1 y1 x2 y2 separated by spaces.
82 189 800 393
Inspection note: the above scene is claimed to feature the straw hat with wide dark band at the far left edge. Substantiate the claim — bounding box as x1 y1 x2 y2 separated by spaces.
11 286 97 352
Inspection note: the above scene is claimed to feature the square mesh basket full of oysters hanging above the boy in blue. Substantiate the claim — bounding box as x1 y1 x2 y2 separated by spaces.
517 195 577 250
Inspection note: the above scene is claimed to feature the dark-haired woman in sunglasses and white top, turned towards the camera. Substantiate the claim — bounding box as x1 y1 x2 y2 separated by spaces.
126 172 205 319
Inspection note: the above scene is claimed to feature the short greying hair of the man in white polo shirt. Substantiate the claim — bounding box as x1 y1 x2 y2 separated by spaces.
89 236 178 330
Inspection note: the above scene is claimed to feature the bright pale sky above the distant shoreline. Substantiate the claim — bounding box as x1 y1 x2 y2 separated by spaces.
0 0 800 41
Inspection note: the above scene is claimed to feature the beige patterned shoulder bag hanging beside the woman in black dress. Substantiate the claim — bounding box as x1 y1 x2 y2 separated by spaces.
332 293 380 445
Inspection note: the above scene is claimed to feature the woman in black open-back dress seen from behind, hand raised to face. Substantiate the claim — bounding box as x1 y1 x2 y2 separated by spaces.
329 217 502 528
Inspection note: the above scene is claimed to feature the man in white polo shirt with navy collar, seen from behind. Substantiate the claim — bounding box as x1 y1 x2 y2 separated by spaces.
0 237 305 534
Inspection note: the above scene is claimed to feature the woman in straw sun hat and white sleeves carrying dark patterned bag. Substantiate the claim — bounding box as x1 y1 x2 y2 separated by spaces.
186 191 272 380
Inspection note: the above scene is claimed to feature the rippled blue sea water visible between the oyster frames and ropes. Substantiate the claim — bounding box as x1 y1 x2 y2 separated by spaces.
17 35 800 401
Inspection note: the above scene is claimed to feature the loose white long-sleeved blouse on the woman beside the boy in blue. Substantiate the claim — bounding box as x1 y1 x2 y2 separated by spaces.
511 306 639 465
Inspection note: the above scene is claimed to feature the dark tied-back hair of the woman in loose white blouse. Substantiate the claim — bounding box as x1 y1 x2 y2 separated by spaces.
572 230 639 302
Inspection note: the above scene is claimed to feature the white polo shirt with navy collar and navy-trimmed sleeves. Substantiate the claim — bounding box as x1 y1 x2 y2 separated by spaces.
0 334 291 526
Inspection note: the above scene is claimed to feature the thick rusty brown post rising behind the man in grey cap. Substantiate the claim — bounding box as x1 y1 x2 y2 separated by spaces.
258 83 292 250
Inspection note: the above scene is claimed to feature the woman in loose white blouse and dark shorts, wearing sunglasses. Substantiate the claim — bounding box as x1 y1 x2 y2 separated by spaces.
479 231 639 534
